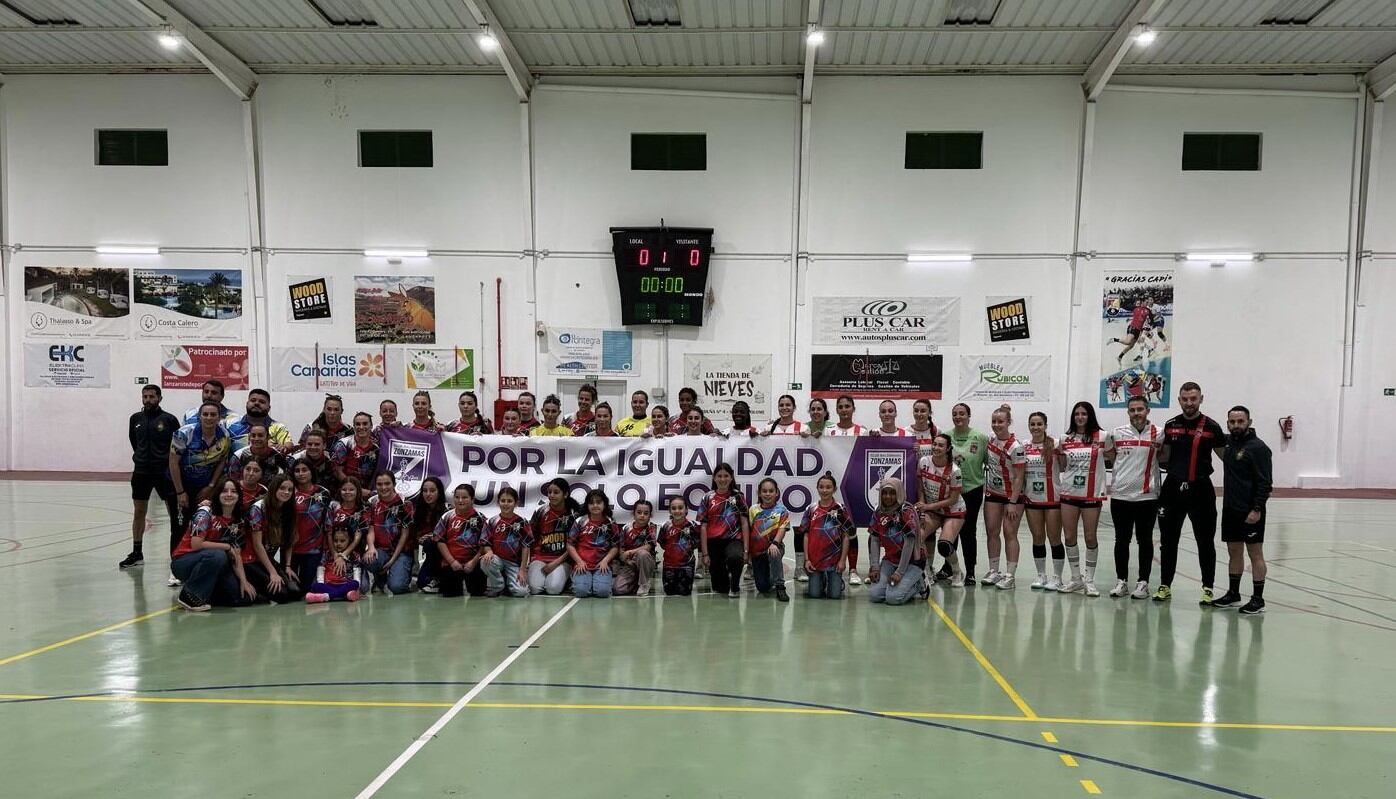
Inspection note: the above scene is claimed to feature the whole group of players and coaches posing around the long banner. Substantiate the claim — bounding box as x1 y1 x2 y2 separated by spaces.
131 380 1272 615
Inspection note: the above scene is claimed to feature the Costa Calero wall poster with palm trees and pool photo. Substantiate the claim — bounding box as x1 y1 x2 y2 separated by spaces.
133 270 243 341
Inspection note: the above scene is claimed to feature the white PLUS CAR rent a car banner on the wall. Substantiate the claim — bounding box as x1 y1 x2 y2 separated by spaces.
814 298 959 346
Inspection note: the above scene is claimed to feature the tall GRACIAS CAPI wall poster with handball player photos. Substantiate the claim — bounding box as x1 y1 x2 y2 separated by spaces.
1100 271 1177 408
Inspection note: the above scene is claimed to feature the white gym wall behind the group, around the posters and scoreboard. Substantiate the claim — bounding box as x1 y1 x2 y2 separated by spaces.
0 75 1396 485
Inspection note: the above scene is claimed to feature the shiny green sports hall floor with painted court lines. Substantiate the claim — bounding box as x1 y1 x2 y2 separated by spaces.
0 482 1396 799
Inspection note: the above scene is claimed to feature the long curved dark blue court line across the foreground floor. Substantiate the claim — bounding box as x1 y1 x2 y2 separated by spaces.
0 680 1262 799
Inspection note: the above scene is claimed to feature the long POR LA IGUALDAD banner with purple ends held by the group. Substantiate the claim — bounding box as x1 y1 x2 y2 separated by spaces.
378 427 916 525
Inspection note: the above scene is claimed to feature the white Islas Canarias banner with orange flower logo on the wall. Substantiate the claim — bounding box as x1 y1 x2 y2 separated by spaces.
271 346 402 391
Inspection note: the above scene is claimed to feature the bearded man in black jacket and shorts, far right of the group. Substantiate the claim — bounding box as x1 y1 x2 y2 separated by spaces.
1212 405 1272 616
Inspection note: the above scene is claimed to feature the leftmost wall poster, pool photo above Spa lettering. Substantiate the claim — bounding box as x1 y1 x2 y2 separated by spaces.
24 267 131 338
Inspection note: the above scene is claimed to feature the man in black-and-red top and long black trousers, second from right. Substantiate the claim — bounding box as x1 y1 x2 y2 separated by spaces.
1153 381 1226 605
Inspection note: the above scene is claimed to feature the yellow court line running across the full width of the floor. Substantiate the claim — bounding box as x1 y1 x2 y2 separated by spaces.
0 694 1396 737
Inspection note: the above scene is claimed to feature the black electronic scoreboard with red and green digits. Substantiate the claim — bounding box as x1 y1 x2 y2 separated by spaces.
610 228 712 325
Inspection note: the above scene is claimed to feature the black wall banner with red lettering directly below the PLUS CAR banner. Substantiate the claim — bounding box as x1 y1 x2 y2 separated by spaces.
810 355 942 400
